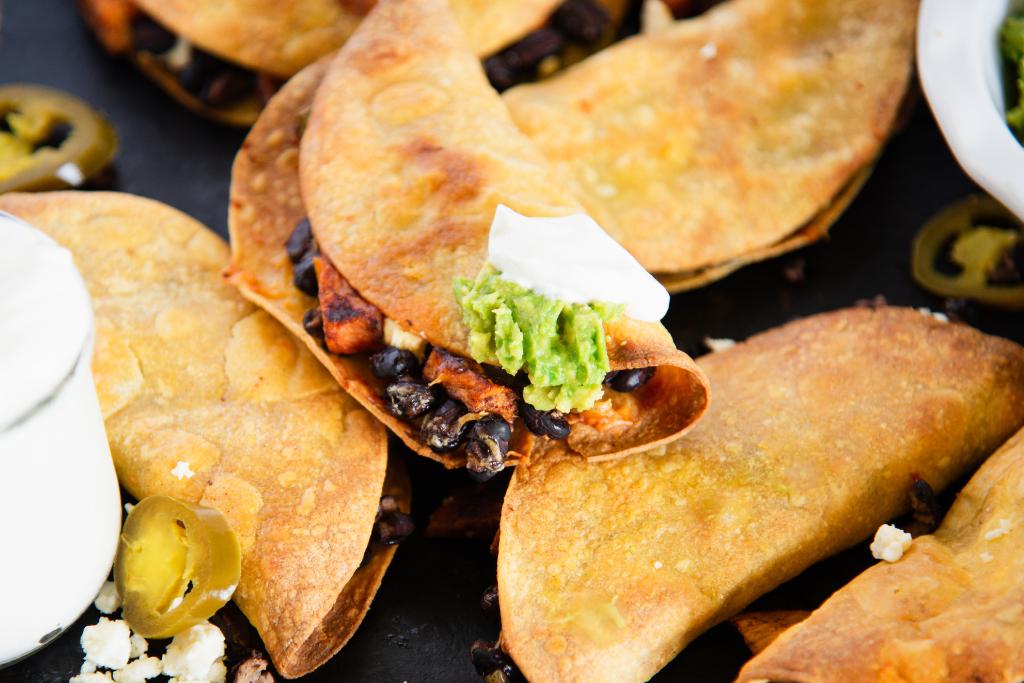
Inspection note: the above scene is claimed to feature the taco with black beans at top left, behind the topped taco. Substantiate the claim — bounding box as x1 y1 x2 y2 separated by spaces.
78 0 559 126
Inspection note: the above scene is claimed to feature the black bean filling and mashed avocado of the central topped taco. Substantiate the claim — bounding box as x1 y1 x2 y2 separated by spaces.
285 219 655 481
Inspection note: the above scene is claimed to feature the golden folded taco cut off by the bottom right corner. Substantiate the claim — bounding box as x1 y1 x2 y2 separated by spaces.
739 431 1024 683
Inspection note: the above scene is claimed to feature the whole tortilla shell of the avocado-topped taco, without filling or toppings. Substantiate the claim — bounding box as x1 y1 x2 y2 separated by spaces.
228 0 709 467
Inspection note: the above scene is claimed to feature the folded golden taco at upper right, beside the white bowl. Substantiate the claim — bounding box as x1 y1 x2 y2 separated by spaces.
504 0 918 279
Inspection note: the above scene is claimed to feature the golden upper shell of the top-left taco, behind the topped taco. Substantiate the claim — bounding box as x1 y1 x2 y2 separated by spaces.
134 0 560 78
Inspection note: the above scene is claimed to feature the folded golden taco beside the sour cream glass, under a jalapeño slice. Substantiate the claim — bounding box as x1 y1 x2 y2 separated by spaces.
0 193 410 678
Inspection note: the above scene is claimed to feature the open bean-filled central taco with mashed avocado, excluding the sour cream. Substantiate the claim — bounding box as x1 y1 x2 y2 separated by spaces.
228 0 709 478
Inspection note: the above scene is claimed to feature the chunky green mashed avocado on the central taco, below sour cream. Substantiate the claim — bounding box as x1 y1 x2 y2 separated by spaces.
455 266 623 413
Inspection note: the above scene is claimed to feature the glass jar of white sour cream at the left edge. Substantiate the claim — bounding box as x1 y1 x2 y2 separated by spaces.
0 213 121 667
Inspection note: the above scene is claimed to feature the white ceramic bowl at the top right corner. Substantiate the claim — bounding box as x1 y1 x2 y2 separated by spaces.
918 0 1024 220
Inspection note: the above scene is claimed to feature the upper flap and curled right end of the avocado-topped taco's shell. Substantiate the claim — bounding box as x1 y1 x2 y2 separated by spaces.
299 0 709 458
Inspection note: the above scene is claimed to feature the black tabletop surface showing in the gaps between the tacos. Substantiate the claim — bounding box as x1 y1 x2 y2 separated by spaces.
0 0 1024 683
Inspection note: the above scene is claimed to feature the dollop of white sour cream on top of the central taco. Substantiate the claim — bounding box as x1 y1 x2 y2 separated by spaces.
487 204 669 323
